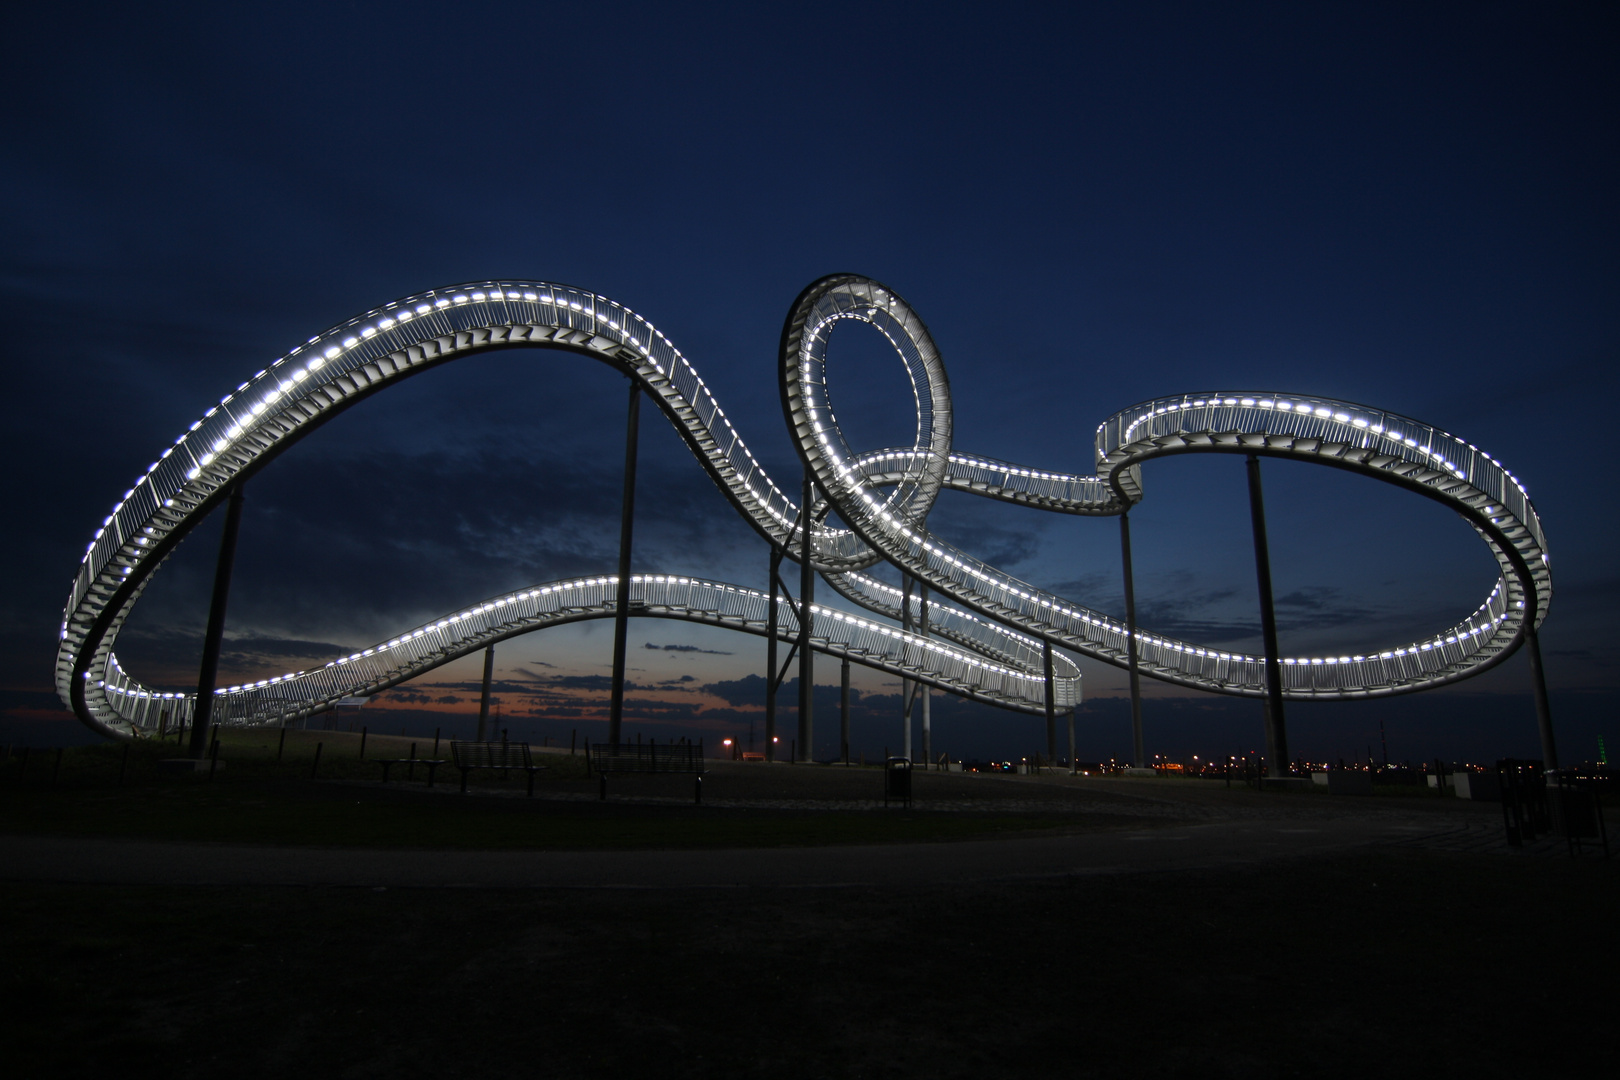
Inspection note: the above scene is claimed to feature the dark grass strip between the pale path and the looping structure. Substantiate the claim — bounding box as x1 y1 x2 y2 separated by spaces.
0 732 1152 850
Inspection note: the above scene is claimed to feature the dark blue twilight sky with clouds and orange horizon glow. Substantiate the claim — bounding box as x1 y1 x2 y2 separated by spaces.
0 3 1620 761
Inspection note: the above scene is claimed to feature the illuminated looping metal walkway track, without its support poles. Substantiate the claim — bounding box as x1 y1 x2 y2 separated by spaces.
57 275 1550 735
